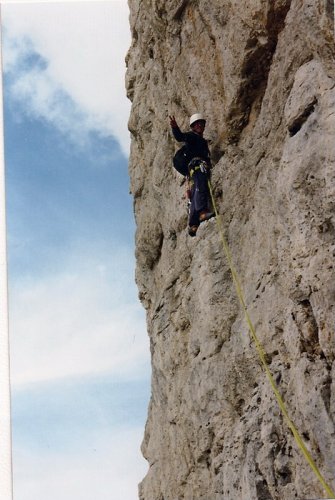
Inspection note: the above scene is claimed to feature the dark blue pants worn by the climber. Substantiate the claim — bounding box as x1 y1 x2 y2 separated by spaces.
189 169 210 226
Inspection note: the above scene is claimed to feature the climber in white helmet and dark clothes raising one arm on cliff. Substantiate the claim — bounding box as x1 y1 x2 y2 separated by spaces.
169 113 215 236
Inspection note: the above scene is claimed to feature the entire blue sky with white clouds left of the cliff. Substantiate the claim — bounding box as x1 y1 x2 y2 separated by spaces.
2 1 150 500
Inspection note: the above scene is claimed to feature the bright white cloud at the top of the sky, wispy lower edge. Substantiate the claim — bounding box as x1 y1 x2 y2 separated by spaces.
3 1 130 153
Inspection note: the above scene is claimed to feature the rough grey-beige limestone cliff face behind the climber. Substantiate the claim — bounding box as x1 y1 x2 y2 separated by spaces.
126 0 335 500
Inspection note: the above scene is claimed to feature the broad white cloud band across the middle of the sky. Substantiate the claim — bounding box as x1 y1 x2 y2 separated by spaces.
10 249 149 384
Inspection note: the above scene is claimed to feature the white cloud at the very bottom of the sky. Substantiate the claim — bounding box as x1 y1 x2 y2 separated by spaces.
14 428 147 500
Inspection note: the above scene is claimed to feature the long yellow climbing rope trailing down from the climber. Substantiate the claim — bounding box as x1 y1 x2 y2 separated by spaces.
208 181 335 498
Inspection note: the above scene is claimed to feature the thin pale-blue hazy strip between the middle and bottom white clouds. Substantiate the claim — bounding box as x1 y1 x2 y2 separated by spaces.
12 375 149 453
